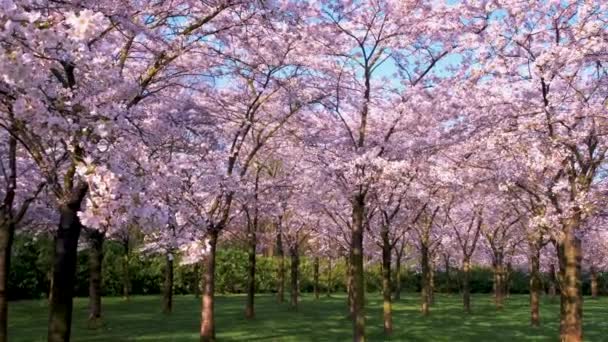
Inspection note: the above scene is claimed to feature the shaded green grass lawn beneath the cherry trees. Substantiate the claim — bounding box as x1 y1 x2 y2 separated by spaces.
9 294 608 342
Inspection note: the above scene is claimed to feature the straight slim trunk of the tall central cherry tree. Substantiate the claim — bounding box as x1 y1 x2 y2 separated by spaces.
350 193 365 342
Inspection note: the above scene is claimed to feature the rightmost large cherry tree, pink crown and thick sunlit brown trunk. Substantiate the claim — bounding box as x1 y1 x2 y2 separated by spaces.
456 2 606 341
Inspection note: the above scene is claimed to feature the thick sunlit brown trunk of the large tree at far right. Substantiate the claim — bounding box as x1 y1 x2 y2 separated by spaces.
558 221 583 342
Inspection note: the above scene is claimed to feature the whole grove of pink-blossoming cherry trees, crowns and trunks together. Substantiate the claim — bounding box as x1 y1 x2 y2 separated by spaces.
0 0 608 341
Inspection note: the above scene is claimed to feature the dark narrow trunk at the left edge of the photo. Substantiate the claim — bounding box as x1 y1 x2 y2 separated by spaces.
0 220 15 342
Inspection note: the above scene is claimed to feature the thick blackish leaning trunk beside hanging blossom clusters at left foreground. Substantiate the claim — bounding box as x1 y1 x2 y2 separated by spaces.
48 185 87 342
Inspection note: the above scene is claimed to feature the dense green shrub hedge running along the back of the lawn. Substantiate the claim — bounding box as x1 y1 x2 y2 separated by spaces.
9 234 608 299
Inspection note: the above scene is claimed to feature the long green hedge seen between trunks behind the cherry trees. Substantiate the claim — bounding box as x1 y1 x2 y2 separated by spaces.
7 234 608 300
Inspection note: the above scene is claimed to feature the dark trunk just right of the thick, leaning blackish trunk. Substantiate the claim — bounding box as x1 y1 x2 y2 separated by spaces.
88 230 105 328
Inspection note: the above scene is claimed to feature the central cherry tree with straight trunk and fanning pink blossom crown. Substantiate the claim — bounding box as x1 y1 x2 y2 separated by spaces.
310 1 492 341
